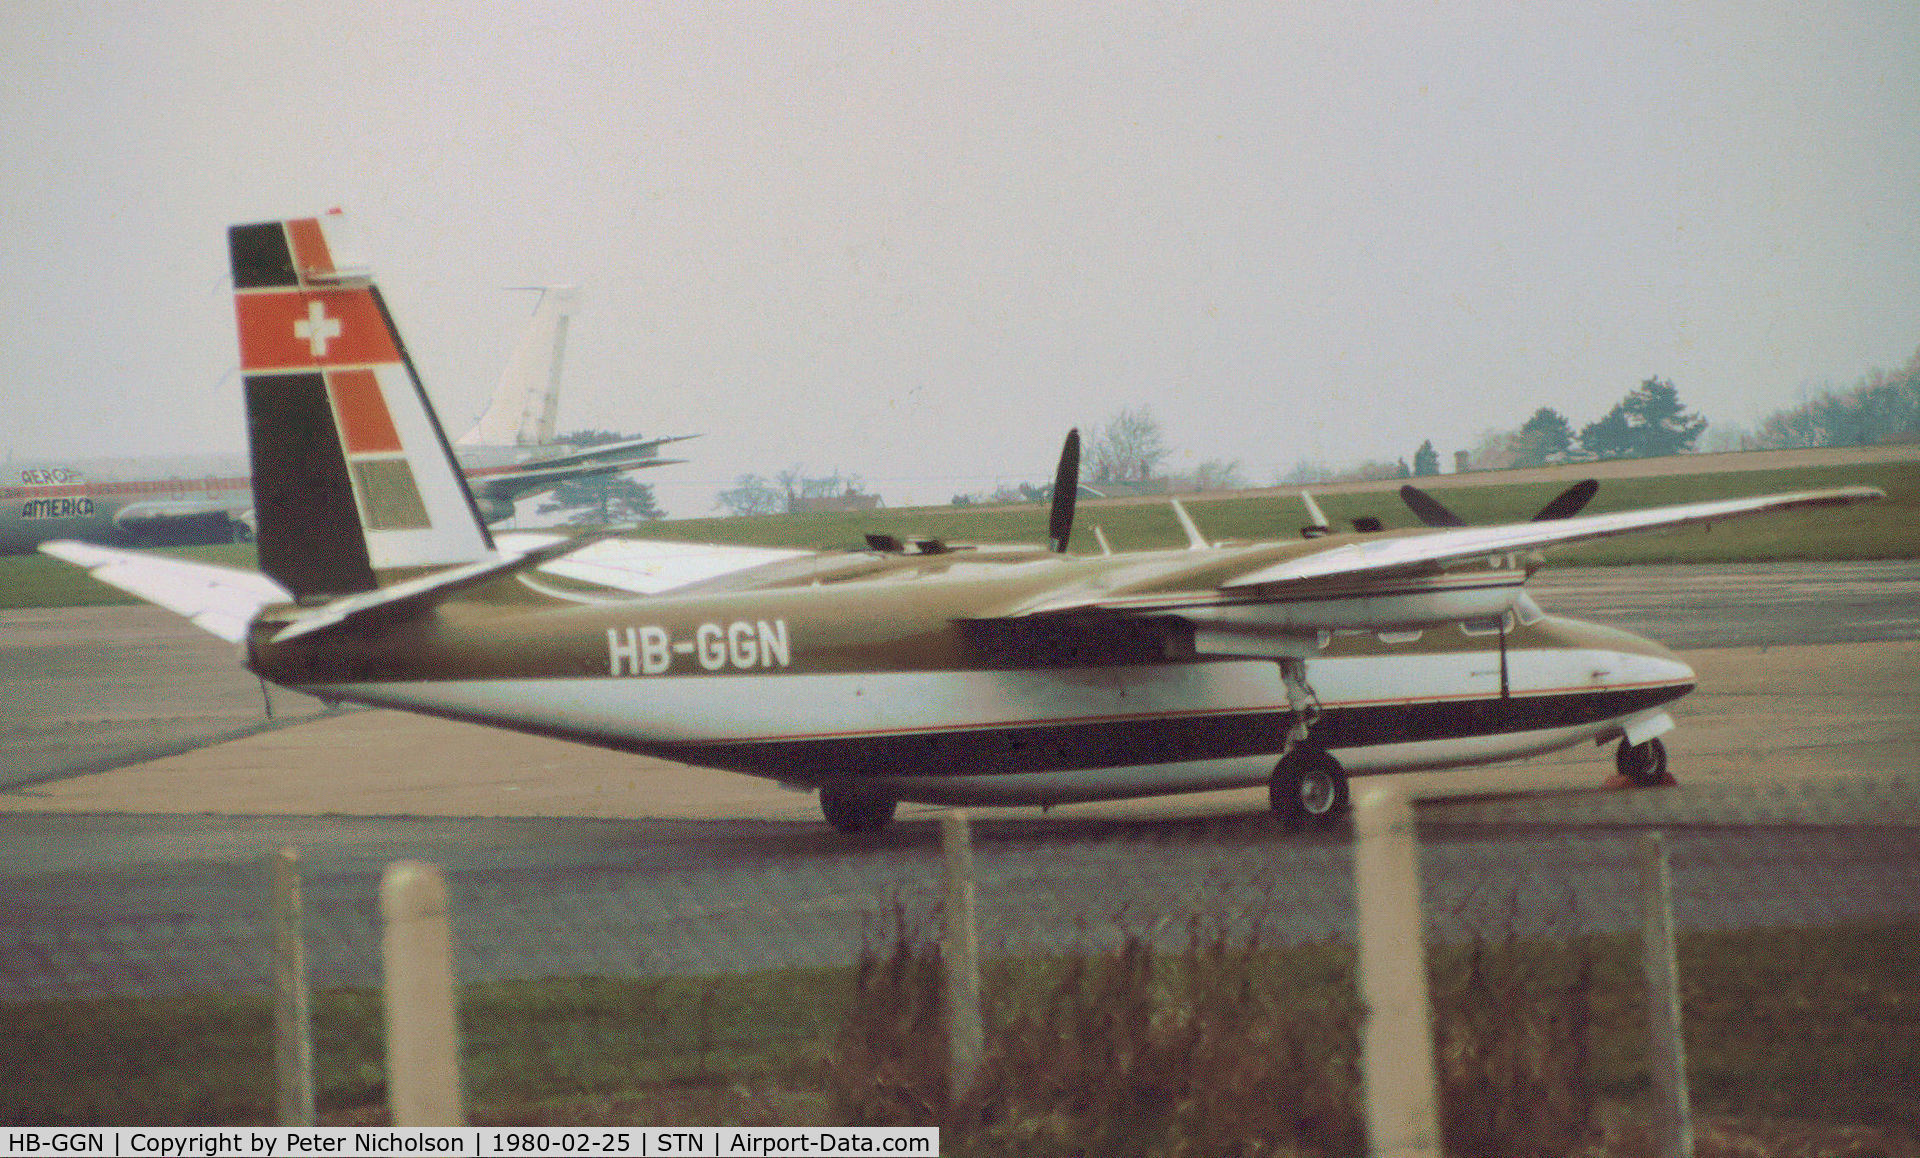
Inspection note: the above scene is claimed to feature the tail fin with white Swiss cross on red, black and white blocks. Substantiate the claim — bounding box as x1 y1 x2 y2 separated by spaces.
227 213 493 601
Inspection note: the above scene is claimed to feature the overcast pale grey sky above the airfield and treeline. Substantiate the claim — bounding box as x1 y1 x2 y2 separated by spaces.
0 0 1920 515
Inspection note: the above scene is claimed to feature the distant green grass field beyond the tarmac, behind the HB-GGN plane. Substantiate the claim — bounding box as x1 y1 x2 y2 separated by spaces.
0 463 1920 607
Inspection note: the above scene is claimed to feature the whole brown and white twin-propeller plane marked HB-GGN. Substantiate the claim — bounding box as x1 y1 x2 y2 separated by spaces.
46 221 1880 832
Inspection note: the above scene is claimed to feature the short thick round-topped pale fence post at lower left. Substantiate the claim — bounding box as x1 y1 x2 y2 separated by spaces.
380 860 465 1125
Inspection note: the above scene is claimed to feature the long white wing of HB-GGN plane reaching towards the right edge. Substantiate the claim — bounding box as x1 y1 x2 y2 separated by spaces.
993 486 1885 618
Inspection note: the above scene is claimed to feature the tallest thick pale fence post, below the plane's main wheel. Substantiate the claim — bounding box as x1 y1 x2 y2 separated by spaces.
1354 787 1440 1158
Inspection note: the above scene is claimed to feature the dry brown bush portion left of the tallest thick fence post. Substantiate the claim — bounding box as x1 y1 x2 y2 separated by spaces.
828 917 1361 1156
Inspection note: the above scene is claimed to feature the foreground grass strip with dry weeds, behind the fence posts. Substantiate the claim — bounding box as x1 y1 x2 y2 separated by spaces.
0 922 1920 1154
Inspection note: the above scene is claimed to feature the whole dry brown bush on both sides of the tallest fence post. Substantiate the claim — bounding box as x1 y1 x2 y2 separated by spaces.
828 910 1635 1156
